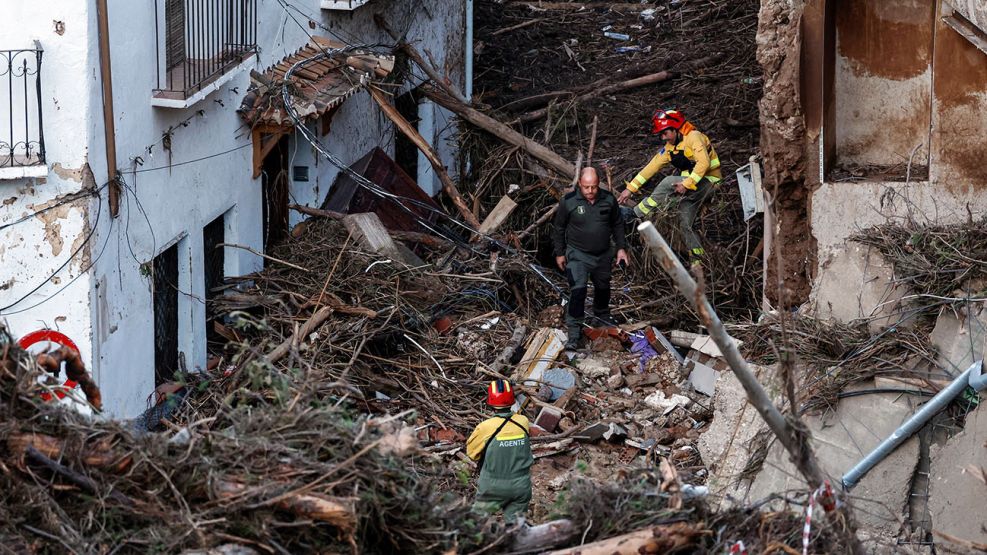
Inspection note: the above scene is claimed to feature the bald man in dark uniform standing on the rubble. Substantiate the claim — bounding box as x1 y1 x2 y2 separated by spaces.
553 167 628 350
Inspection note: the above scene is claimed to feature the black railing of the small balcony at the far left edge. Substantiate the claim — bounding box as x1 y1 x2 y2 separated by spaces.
0 42 45 168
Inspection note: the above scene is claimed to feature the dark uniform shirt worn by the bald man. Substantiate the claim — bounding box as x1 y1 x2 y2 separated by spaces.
552 188 626 256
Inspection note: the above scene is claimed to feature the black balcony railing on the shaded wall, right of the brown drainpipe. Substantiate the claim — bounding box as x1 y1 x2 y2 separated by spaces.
155 0 257 98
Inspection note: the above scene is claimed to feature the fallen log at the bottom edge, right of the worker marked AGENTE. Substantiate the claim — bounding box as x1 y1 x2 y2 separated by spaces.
551 522 711 555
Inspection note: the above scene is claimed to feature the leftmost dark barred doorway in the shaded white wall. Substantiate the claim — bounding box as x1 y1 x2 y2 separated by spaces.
151 244 178 387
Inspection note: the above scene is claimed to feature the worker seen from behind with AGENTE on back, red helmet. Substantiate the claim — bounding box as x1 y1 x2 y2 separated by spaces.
466 380 535 522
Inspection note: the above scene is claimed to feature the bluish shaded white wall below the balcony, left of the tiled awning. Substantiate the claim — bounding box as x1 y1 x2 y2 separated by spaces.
90 0 318 416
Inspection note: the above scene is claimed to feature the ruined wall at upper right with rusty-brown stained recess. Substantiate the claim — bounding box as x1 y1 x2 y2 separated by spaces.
758 0 987 325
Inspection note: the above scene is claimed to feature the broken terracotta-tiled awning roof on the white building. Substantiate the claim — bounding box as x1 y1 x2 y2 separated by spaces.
238 37 394 127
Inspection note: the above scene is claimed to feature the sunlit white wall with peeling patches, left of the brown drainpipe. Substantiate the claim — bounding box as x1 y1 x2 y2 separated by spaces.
0 0 98 380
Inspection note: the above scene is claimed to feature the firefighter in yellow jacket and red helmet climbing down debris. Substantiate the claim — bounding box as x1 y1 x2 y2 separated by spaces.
617 110 722 264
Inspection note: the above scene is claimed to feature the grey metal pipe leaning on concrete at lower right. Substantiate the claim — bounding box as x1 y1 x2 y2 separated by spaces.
843 360 987 491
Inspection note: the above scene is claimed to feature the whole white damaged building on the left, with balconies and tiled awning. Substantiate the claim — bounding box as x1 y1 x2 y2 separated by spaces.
0 0 472 417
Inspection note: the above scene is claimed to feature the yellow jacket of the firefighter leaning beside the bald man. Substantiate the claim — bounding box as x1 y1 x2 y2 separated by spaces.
627 122 723 193
